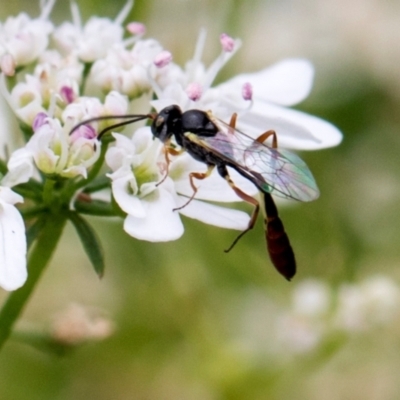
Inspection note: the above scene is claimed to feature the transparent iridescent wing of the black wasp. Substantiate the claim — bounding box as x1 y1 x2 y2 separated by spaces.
195 120 319 201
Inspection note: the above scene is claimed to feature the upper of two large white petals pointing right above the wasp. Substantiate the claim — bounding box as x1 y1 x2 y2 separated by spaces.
218 58 314 106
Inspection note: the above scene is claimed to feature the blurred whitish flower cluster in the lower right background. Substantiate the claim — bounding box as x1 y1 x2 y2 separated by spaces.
232 275 400 360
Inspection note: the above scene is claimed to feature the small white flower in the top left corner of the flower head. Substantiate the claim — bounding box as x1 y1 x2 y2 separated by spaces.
0 0 54 75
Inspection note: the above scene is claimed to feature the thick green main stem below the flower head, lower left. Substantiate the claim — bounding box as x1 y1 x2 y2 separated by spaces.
0 214 66 350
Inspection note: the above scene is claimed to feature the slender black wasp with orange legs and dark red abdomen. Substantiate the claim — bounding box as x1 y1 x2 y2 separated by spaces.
73 105 319 280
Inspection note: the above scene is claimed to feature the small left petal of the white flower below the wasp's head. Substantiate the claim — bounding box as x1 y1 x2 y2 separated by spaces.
111 175 146 218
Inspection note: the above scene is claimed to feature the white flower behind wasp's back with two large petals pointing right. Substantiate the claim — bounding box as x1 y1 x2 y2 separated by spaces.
152 33 342 150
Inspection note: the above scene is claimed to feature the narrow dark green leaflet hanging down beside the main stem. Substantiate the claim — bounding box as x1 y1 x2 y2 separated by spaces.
68 212 104 278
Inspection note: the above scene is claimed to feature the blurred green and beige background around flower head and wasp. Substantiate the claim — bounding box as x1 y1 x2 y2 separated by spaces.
0 0 400 400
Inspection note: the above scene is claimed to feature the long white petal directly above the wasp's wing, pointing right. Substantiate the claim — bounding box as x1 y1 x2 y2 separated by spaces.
238 103 342 150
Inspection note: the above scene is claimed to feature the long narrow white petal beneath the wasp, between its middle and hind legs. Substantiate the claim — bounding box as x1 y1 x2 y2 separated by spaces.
179 197 250 231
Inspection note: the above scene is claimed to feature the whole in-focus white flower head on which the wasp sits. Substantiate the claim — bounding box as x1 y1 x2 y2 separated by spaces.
0 0 341 290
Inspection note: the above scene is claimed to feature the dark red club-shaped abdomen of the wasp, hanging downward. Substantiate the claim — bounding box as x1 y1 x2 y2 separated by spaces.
263 193 296 281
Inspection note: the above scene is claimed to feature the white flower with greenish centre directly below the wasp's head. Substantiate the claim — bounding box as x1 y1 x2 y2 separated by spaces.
106 127 249 242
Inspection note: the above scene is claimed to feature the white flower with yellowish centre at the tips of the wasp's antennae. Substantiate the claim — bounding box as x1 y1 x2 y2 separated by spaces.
3 92 128 186
